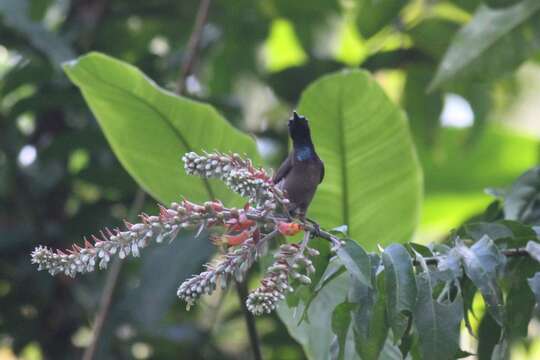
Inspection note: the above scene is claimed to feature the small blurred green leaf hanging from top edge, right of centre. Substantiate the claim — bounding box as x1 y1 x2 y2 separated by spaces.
356 0 407 38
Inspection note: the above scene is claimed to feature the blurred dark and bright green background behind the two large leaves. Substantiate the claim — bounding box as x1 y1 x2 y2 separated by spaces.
0 0 540 359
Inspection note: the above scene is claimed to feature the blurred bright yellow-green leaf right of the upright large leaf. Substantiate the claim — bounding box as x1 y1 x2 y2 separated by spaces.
418 124 538 234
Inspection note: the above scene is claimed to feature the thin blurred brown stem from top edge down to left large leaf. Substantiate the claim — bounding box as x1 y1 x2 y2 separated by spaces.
176 0 211 95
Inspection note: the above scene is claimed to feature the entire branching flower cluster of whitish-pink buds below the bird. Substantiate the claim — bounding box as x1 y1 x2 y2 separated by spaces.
32 152 334 315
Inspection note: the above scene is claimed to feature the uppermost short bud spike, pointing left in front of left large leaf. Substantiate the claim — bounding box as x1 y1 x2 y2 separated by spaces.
182 152 288 207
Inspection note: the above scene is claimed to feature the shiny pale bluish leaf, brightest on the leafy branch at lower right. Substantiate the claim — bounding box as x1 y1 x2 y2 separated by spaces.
456 235 506 326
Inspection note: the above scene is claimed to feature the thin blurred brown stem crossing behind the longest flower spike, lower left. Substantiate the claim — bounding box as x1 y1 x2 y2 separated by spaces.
82 188 146 360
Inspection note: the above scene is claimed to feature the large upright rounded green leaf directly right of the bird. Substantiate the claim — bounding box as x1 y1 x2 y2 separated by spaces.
299 70 422 248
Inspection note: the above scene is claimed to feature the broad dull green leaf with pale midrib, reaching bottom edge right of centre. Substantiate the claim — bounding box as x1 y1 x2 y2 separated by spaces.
413 273 463 360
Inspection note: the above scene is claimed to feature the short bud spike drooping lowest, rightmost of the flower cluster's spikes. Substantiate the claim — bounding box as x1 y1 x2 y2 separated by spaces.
246 244 319 315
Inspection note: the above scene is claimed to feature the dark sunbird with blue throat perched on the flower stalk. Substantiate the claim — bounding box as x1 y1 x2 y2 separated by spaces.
272 111 324 220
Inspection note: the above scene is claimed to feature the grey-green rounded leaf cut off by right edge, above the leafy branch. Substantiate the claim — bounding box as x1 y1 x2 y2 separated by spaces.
504 167 540 224
